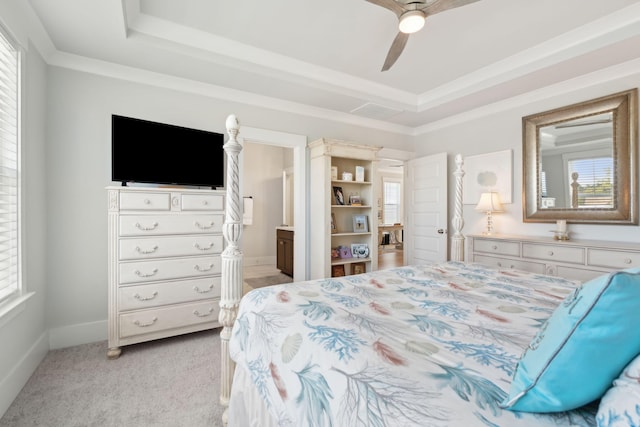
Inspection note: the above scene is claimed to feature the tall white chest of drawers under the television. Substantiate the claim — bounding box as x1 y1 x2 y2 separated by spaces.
107 187 224 359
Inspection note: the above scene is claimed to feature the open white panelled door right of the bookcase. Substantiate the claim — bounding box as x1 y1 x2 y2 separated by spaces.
404 153 448 265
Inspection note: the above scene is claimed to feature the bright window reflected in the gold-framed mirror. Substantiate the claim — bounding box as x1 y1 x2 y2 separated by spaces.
568 155 613 208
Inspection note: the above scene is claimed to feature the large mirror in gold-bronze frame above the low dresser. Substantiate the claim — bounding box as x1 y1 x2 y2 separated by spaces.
522 89 638 224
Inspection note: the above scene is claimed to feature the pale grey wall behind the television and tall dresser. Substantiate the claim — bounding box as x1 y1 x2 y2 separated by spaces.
46 67 410 348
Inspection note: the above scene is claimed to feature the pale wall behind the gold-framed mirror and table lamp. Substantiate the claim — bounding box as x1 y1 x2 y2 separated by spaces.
416 67 640 247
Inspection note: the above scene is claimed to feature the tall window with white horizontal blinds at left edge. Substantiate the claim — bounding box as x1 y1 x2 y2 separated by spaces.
0 28 20 302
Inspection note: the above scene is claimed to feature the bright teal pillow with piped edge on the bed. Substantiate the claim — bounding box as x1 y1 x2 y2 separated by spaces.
503 269 640 412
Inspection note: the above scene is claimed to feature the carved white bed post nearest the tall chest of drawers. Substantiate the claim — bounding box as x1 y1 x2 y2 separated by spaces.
218 115 242 425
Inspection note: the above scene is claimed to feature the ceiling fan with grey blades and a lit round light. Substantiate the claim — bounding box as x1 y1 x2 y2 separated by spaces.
367 0 479 71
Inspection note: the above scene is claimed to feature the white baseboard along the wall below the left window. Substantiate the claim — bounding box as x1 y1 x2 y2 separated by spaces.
0 332 49 417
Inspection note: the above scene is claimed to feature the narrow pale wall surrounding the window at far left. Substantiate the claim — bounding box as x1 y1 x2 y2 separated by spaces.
0 2 49 416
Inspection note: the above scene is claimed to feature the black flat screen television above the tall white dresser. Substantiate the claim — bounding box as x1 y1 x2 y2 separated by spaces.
111 114 225 188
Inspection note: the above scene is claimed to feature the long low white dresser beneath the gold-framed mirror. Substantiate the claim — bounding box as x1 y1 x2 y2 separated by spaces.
467 235 640 282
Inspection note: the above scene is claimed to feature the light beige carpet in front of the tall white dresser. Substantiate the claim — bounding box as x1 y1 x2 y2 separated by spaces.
0 329 222 427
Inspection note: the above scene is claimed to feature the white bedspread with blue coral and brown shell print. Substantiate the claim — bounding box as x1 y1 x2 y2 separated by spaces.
230 262 597 427
